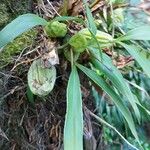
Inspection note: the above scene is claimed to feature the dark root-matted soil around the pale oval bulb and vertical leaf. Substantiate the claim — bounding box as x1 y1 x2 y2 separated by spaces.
0 54 100 150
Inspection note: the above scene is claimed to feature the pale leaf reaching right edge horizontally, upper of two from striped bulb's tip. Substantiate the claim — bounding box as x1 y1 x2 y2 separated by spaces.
119 25 150 41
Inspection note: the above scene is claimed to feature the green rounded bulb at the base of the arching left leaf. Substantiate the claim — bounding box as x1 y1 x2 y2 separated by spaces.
44 21 67 38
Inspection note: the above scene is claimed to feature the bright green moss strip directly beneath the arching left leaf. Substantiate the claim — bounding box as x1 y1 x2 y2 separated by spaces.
0 29 37 68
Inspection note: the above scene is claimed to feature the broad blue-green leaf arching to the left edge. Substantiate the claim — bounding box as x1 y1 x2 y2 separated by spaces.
0 14 47 48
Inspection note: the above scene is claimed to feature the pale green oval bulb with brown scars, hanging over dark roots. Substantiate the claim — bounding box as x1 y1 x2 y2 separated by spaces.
28 59 56 96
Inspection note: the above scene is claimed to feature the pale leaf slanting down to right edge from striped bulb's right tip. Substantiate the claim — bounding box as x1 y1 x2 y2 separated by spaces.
120 42 150 77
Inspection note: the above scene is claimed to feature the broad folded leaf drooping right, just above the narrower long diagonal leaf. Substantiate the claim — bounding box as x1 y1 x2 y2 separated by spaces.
90 48 141 122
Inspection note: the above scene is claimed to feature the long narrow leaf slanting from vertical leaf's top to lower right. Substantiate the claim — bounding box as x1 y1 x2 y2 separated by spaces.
77 64 140 143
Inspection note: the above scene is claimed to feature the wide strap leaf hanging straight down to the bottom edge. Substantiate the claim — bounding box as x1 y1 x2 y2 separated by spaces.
64 66 83 150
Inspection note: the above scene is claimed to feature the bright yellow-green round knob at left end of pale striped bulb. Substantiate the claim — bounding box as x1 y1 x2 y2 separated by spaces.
69 33 88 53
